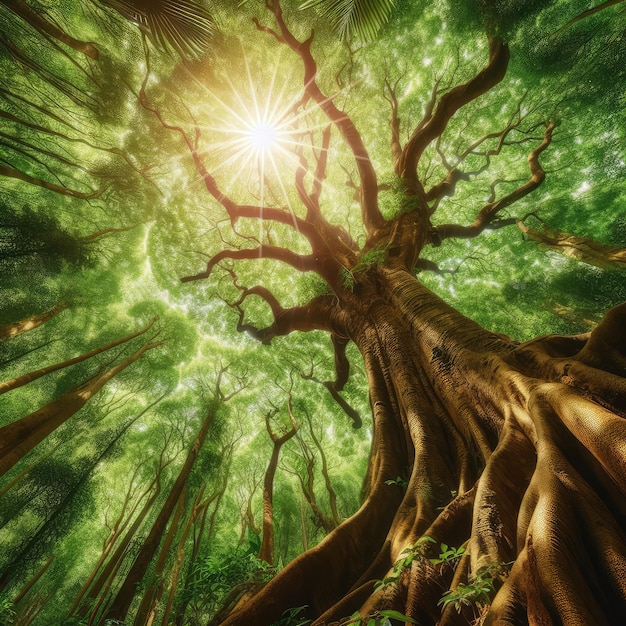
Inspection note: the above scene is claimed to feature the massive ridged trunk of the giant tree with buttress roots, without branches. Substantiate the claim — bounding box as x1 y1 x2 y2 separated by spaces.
224 267 626 626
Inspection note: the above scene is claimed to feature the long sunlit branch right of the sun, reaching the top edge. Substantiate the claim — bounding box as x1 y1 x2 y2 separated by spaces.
254 0 385 233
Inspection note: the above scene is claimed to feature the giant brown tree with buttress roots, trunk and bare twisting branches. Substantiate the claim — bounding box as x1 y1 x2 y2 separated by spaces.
165 0 626 626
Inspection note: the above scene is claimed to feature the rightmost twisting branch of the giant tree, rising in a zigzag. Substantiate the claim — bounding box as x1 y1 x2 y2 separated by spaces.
437 122 556 240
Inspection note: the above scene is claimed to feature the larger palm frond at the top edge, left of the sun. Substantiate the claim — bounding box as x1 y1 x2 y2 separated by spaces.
100 0 217 59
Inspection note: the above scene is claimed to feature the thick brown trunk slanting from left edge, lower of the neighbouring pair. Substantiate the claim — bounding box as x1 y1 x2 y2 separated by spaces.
0 332 161 475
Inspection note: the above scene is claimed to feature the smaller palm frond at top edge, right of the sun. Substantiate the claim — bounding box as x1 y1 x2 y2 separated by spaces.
300 0 395 41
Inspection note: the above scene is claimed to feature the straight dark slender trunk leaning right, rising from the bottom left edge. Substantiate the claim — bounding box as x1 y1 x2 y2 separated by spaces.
102 404 217 623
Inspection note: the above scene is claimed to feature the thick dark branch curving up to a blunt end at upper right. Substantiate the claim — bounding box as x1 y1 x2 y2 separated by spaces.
398 37 509 193
